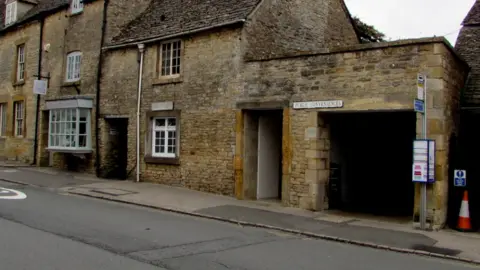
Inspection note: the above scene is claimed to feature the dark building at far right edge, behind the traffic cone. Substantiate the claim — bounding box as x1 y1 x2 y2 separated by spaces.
450 0 480 229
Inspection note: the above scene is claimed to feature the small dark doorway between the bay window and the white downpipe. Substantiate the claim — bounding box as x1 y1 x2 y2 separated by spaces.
103 118 128 180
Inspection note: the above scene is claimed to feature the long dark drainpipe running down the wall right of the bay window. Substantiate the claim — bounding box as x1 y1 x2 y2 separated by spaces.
95 0 109 177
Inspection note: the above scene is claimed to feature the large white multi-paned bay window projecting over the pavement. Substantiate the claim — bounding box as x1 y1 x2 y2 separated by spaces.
48 108 91 150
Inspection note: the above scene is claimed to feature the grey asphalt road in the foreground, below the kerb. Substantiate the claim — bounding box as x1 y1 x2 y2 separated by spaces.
0 182 479 270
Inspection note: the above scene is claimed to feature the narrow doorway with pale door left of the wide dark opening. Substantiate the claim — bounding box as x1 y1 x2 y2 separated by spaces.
244 110 283 200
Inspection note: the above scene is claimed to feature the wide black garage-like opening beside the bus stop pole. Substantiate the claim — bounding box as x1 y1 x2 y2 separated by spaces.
324 112 416 217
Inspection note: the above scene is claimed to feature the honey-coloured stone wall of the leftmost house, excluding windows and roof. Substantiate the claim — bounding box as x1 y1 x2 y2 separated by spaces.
0 22 40 163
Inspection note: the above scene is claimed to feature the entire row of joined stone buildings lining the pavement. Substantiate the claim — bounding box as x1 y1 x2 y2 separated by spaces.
0 0 469 226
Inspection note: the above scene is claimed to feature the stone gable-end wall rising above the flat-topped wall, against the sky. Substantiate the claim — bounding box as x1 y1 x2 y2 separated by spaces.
243 0 358 60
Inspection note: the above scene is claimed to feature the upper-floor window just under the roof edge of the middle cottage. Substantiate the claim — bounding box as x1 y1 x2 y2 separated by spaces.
158 39 183 78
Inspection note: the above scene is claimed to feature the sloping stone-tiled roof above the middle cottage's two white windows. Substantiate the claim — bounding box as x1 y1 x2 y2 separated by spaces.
111 0 260 45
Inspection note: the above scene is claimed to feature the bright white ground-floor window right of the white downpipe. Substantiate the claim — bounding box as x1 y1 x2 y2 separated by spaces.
152 117 177 158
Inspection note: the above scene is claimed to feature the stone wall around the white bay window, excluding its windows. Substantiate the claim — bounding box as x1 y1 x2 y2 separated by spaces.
38 1 103 173
